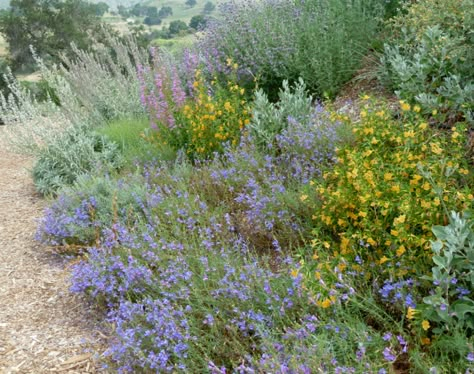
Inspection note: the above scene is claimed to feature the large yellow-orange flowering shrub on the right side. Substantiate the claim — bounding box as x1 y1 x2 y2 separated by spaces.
304 101 474 285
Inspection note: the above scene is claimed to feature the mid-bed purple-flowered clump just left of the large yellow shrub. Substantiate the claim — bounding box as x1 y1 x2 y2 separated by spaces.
206 106 339 247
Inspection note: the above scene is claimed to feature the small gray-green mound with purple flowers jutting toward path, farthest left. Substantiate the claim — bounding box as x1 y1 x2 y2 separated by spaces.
36 175 147 249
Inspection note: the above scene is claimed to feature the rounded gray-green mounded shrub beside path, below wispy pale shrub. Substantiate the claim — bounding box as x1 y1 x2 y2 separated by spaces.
32 126 122 195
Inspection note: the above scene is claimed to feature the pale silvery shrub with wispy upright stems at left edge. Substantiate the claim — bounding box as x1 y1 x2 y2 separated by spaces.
0 31 149 153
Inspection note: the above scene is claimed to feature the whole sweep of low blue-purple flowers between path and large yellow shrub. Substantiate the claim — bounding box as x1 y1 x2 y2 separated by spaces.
35 109 412 373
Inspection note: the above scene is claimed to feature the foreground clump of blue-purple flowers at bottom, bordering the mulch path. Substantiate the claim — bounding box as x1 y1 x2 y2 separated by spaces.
68 211 318 372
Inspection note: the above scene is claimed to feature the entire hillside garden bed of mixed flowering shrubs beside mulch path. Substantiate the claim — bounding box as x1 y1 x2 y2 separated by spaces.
0 0 474 374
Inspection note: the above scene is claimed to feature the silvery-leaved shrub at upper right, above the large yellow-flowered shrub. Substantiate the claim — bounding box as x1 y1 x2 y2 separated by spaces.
382 26 474 122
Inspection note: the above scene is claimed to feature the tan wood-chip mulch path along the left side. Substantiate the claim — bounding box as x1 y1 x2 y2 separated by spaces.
0 130 107 374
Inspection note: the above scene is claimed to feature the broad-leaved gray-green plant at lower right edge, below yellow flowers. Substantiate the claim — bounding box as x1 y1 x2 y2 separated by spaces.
423 212 474 334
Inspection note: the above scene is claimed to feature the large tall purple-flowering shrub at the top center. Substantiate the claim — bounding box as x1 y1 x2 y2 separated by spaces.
200 0 383 96
